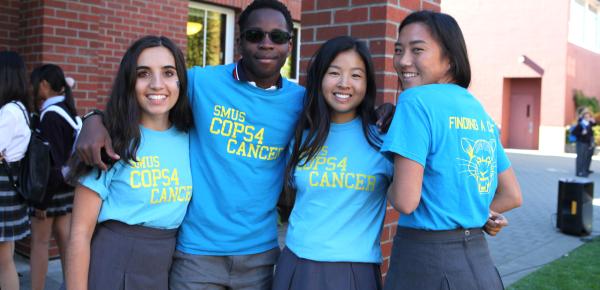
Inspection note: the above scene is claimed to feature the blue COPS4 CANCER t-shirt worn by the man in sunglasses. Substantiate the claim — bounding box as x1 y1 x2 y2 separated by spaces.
177 64 304 255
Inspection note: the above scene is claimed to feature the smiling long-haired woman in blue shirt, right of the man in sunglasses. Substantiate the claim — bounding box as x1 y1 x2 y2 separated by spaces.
273 36 392 290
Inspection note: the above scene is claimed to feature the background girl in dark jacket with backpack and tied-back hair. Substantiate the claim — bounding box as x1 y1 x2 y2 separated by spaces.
30 64 77 290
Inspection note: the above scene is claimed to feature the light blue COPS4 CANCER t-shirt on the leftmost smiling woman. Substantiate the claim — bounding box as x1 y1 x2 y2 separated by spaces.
80 126 192 229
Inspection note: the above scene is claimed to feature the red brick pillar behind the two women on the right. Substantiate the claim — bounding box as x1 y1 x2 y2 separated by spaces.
300 0 440 276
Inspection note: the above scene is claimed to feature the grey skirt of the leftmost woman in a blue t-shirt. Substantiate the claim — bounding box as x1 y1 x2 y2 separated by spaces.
88 221 177 290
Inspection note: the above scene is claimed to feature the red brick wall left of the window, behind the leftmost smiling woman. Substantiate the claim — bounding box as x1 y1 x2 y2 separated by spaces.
25 0 187 112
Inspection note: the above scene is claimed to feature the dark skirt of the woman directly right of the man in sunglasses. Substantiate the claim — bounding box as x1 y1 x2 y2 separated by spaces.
273 248 381 290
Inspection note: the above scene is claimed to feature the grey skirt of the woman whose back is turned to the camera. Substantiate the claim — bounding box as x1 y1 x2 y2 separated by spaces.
384 227 504 290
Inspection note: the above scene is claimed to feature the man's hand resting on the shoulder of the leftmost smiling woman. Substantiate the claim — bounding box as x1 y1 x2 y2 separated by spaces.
75 114 121 170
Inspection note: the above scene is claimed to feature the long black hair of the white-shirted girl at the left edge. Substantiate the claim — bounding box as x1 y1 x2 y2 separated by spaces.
0 51 32 111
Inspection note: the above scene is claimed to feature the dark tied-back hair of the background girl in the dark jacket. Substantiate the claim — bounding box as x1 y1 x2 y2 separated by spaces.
30 64 77 116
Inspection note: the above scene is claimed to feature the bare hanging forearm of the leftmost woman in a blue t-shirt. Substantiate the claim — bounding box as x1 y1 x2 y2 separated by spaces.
65 185 102 290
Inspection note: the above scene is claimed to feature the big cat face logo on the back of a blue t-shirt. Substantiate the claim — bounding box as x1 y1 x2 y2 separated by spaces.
458 138 496 194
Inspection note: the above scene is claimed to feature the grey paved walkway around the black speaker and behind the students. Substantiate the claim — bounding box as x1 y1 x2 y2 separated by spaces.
12 150 600 290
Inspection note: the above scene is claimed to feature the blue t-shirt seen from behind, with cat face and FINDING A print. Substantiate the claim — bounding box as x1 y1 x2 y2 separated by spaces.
381 84 510 230
